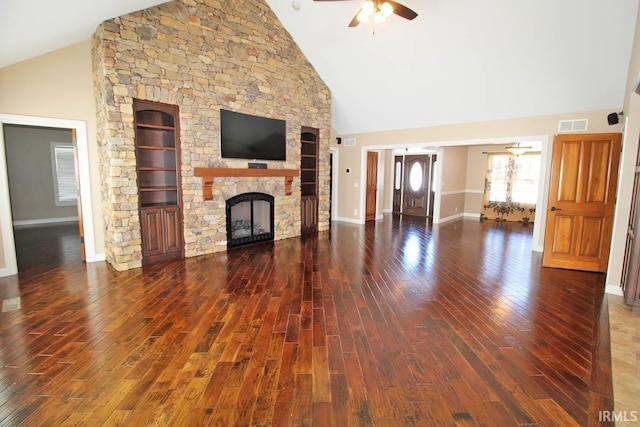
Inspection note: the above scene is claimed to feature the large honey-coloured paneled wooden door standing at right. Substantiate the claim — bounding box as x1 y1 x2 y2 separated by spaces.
542 133 621 272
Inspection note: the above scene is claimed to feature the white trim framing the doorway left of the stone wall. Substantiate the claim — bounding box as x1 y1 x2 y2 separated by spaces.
0 114 96 277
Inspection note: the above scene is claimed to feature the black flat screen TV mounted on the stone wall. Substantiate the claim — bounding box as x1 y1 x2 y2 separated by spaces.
220 109 287 160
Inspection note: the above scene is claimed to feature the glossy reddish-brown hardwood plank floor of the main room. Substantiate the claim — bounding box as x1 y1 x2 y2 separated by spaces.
0 216 613 426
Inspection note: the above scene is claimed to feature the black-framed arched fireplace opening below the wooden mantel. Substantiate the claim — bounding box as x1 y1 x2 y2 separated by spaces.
226 193 274 248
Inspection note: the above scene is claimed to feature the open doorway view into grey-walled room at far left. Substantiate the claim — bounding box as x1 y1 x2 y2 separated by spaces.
3 124 84 272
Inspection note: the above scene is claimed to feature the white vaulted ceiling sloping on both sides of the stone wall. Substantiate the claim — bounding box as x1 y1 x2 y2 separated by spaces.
0 0 638 134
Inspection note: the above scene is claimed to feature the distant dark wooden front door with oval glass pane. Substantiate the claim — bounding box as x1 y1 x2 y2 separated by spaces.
402 156 431 217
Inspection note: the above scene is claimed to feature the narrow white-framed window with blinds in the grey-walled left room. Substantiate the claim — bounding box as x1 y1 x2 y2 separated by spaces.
51 142 78 206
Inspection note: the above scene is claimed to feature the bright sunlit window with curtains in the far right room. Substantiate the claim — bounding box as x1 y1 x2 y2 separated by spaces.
488 153 540 204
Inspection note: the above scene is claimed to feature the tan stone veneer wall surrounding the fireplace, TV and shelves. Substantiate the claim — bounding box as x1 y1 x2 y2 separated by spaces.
93 0 331 270
